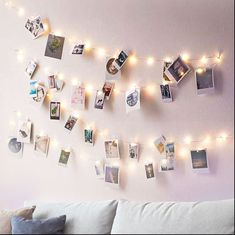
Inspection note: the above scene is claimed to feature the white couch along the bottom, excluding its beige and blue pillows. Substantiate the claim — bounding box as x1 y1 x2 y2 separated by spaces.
25 199 234 234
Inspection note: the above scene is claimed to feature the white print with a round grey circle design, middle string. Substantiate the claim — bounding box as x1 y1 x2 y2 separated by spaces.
125 88 140 113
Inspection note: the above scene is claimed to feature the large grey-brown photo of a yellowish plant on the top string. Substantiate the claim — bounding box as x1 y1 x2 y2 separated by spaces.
45 34 65 59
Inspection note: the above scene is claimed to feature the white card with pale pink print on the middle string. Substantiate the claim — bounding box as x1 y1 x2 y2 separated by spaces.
71 86 86 110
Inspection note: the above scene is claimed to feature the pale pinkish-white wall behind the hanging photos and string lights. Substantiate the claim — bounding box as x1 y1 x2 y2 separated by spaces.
0 0 234 208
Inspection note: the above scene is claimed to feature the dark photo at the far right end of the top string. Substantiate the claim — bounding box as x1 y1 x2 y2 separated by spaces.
195 68 215 95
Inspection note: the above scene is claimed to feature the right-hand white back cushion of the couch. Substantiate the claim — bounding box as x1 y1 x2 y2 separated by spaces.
112 200 234 234
